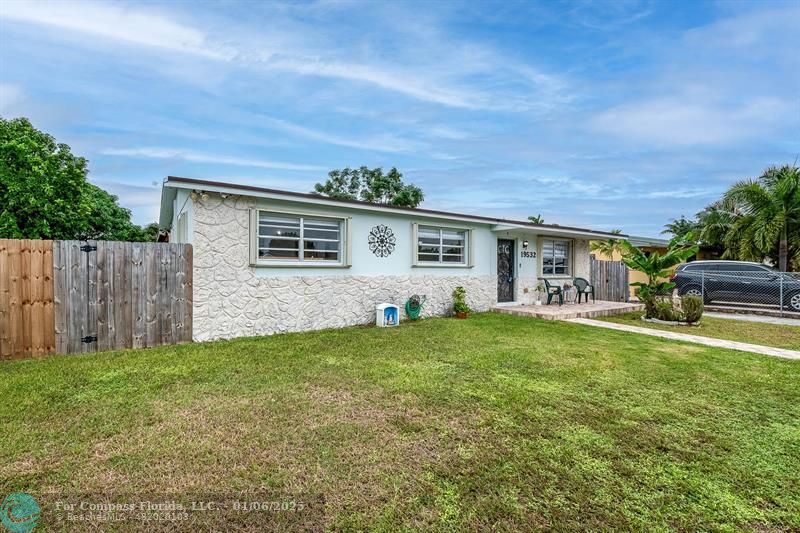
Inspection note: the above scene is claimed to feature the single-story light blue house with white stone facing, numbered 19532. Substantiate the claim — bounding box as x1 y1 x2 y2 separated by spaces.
159 177 624 340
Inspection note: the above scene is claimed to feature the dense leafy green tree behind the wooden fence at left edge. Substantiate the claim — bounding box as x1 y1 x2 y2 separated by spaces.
0 117 158 241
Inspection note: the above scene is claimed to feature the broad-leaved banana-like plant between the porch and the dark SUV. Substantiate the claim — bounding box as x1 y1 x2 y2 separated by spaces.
620 232 699 318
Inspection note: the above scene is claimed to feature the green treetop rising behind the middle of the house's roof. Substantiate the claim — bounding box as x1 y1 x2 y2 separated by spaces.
313 166 424 207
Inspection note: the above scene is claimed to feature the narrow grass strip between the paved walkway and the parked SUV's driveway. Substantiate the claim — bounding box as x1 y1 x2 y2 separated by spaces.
597 311 800 350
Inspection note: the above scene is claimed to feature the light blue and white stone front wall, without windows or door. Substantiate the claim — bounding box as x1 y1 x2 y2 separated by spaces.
186 191 589 340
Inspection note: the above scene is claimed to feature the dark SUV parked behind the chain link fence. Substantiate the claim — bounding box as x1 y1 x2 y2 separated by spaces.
670 261 800 312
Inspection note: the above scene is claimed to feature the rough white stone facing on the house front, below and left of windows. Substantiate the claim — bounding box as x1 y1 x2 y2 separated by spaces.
193 194 497 340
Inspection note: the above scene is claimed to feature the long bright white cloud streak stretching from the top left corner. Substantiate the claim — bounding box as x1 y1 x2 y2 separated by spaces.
0 1 567 111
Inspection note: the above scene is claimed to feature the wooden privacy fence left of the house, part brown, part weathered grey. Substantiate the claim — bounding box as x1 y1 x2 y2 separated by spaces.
0 239 192 358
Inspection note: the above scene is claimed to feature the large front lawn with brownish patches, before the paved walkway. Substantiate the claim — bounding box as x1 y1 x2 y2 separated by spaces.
0 314 800 531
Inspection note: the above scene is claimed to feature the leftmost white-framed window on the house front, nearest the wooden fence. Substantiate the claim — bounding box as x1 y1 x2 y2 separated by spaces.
256 211 344 264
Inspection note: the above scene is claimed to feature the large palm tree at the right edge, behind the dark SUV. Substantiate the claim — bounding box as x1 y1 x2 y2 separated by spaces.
725 165 800 272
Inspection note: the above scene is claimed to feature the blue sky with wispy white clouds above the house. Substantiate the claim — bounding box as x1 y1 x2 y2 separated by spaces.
0 0 800 236
